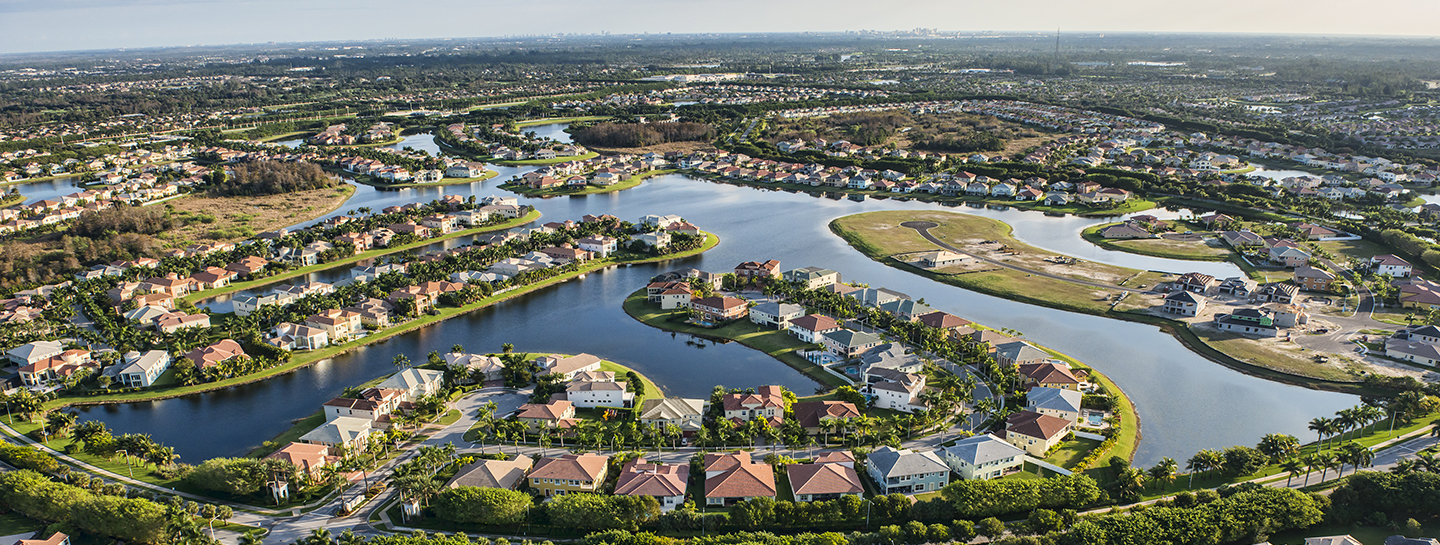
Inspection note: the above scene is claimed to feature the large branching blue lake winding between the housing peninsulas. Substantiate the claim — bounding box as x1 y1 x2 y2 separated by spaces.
81 174 1358 464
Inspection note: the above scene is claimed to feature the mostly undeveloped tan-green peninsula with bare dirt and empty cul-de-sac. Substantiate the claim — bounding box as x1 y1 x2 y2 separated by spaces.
831 211 1393 391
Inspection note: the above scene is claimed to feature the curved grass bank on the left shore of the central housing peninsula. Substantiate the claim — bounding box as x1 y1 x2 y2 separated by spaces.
625 288 850 388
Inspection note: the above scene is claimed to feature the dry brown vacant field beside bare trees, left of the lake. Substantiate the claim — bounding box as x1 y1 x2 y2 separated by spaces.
166 186 354 245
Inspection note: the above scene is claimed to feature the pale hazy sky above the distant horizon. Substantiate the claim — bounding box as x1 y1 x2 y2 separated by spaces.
0 0 1440 53
